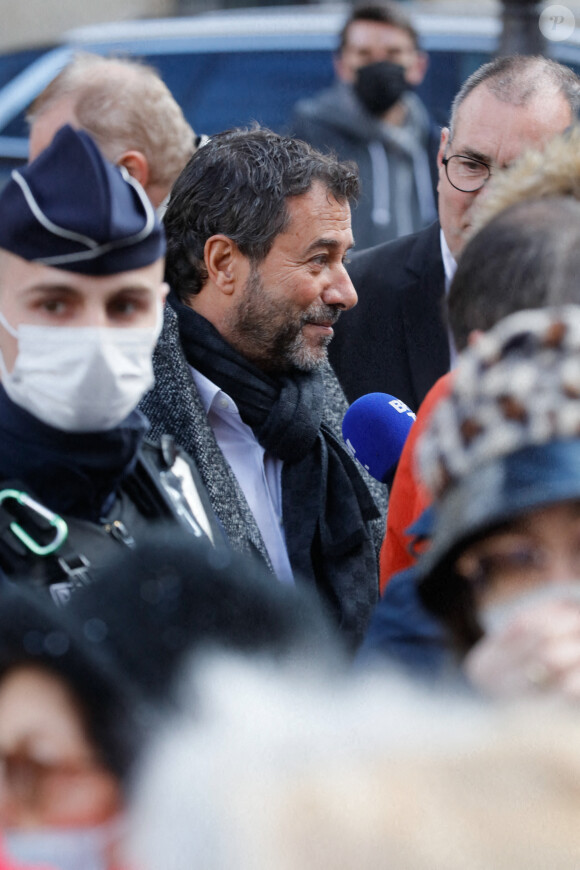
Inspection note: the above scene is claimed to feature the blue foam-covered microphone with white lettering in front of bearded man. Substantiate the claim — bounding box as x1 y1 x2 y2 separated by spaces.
342 393 415 483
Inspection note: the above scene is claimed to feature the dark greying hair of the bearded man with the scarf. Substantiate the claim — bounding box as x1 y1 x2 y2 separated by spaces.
164 127 359 301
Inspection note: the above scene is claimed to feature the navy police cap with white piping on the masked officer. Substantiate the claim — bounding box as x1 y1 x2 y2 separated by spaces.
0 125 165 275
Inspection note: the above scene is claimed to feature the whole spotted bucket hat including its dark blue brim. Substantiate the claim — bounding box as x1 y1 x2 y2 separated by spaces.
417 305 580 576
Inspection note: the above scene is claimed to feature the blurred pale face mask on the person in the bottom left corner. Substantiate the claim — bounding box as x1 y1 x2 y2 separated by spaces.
2 820 119 870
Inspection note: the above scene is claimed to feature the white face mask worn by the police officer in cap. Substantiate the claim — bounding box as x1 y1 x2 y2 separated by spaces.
0 302 163 432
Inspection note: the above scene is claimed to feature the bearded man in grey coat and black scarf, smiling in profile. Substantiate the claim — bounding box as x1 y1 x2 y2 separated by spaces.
140 127 387 645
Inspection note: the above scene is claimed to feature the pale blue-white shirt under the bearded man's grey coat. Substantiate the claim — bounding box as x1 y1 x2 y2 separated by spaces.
191 367 294 583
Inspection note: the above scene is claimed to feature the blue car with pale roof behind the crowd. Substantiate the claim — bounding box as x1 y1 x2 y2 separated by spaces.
0 2 580 181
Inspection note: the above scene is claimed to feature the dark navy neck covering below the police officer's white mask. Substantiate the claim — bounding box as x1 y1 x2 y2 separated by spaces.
0 386 148 522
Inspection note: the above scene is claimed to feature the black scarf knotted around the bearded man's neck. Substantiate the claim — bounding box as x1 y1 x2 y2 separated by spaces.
171 294 379 630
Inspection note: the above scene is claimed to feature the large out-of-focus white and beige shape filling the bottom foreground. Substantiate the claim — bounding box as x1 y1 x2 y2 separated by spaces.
129 659 580 870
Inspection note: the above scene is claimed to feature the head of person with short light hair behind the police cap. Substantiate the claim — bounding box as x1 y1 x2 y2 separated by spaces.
27 53 196 208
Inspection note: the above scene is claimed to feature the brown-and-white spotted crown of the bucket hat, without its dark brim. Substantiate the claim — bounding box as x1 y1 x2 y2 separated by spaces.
418 305 580 499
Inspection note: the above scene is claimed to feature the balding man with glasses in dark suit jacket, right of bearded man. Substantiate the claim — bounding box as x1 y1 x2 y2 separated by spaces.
329 56 580 410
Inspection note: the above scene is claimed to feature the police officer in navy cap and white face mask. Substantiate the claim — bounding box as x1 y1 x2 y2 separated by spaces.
0 126 221 600
